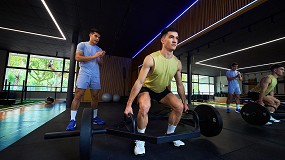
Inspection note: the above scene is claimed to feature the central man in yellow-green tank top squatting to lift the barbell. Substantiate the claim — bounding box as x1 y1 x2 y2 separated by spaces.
124 27 188 155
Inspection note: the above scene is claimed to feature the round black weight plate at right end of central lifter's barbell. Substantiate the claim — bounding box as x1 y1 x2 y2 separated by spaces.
194 104 223 137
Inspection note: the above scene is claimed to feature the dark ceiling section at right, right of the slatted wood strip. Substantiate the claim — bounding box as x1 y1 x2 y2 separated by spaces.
175 0 285 76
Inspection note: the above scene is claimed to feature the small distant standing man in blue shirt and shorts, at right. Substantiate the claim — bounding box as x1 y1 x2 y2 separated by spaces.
226 62 242 113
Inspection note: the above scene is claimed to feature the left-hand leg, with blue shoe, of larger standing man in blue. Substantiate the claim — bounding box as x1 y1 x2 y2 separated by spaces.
66 88 85 131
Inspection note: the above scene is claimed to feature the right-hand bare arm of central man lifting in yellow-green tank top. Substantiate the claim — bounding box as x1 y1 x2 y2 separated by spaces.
174 61 188 111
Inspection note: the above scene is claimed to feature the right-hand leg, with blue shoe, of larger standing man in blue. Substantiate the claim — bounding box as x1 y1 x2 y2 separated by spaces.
90 89 105 125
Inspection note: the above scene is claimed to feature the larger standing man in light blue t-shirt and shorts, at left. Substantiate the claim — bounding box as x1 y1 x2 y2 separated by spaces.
66 28 105 131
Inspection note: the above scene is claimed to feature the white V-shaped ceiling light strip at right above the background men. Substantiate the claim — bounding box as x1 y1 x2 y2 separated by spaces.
195 37 285 70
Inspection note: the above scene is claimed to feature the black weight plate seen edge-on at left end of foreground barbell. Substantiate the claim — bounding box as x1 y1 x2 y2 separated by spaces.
79 108 93 160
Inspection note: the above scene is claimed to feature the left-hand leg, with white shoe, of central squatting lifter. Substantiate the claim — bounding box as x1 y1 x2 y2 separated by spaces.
134 92 151 155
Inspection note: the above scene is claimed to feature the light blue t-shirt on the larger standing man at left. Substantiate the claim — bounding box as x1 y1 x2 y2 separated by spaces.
76 42 102 77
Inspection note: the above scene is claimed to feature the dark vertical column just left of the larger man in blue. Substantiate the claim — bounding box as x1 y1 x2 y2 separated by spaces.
66 31 78 108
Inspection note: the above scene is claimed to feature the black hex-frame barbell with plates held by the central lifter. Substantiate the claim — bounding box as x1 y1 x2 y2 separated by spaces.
44 104 223 160
